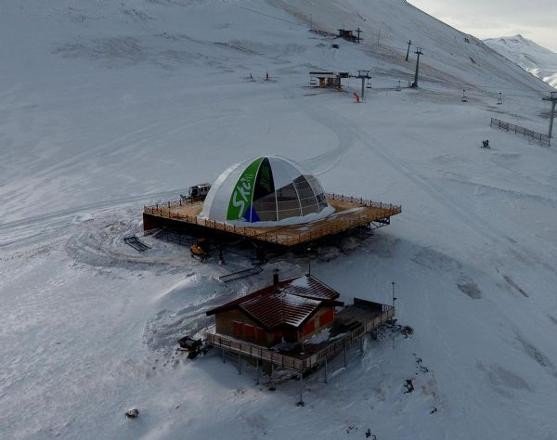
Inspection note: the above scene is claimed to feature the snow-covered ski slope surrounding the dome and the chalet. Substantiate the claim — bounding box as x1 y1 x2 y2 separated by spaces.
0 0 557 440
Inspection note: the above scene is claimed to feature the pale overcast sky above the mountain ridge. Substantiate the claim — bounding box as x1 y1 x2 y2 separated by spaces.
408 0 557 52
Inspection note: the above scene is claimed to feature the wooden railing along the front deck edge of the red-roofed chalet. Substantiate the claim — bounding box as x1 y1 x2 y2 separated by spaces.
206 305 395 372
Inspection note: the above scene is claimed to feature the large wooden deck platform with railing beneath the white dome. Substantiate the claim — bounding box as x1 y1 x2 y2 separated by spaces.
143 194 401 247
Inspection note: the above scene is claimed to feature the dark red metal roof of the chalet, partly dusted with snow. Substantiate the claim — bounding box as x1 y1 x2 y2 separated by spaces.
207 275 342 329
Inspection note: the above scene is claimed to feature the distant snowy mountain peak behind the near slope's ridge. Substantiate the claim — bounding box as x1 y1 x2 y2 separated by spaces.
484 35 557 88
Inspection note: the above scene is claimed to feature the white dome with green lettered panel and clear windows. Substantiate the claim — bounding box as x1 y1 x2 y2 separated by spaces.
201 156 333 226
